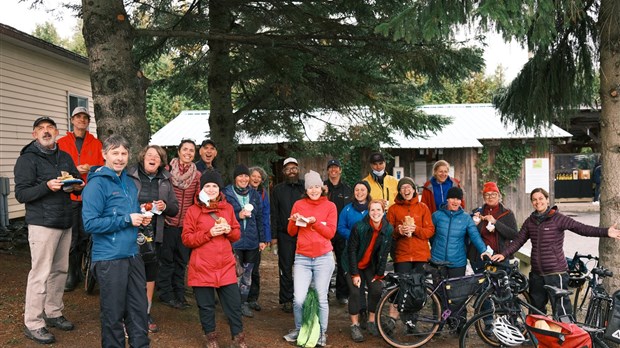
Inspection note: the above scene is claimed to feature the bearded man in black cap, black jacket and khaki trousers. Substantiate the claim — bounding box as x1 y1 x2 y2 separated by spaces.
14 117 84 344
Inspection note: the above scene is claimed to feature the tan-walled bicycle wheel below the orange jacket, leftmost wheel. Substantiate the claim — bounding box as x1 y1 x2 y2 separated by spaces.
375 287 441 348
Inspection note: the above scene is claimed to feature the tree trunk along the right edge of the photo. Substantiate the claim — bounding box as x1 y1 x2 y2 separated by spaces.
598 0 620 289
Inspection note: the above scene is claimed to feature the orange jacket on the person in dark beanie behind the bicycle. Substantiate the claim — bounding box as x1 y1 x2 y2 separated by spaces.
387 193 435 262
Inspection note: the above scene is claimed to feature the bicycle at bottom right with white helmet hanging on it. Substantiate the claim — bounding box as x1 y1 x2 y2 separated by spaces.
459 276 608 348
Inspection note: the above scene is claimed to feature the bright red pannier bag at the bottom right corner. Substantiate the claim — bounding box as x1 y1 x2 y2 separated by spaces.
525 314 592 348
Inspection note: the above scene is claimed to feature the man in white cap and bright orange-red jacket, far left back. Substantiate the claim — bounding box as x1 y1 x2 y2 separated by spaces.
58 106 104 291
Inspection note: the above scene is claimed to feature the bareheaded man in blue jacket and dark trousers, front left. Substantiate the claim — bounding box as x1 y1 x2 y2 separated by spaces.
82 135 151 347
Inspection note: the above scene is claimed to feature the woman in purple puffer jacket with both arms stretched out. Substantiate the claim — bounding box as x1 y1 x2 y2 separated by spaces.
491 188 620 315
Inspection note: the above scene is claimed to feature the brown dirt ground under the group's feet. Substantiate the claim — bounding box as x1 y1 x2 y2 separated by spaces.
0 250 458 348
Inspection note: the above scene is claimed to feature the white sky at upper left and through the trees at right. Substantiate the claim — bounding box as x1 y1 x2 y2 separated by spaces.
0 0 527 81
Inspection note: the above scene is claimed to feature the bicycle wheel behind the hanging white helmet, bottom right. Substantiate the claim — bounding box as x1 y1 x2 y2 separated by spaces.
459 309 534 348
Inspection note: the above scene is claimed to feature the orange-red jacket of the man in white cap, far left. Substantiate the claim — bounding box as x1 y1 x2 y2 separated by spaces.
58 131 104 201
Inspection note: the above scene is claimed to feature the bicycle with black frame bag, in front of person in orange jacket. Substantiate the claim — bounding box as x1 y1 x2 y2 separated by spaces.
376 260 487 348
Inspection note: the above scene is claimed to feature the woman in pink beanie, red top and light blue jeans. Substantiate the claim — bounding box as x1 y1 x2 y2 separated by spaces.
284 170 338 347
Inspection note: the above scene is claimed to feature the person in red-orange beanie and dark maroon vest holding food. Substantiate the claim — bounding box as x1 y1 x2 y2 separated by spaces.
467 182 518 334
